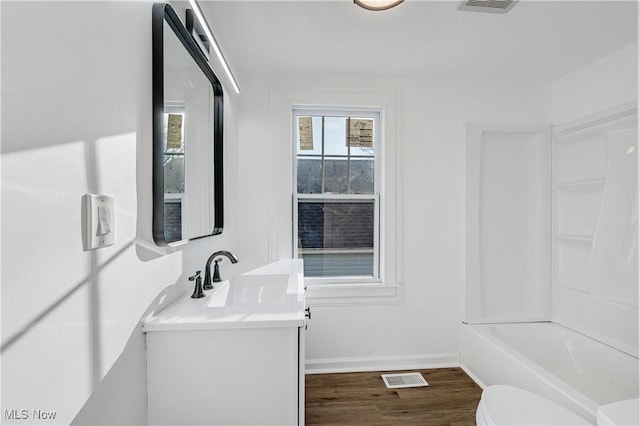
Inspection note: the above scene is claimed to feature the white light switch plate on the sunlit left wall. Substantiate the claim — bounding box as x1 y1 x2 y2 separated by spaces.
82 194 116 251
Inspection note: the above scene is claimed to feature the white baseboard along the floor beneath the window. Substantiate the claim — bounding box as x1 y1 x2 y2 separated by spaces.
305 353 460 374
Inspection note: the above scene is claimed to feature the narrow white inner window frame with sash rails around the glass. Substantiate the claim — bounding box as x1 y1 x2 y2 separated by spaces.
292 107 384 288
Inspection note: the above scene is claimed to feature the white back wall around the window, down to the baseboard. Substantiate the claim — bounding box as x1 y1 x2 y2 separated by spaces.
238 75 549 371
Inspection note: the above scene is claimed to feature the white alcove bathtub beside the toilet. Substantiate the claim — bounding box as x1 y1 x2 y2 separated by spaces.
460 322 638 424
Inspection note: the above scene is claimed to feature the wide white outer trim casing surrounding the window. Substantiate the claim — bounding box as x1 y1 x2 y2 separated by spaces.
264 85 405 306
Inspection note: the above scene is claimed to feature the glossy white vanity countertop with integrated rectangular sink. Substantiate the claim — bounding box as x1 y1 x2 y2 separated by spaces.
143 259 305 332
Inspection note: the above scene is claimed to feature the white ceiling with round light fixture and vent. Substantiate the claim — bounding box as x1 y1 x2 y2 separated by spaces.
200 0 638 81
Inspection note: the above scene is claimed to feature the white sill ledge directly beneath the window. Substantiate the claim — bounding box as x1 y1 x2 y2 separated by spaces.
306 283 400 306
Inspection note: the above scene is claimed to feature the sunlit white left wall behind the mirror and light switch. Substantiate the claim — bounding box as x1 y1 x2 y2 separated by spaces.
1 1 241 424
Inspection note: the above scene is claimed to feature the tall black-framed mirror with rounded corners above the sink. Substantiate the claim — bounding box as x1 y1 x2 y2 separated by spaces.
152 3 224 246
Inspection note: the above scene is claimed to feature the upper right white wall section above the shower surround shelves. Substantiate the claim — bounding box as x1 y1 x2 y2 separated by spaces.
551 41 638 126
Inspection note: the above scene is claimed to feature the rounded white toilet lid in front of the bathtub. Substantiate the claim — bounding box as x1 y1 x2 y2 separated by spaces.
476 385 592 426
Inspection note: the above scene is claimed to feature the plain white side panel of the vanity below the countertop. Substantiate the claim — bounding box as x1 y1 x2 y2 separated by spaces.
147 327 300 425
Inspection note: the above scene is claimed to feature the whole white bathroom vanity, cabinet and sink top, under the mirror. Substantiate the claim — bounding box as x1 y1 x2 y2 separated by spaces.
144 260 305 425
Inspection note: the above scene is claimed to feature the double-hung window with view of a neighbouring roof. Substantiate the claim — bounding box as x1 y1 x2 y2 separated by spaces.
293 109 380 282
